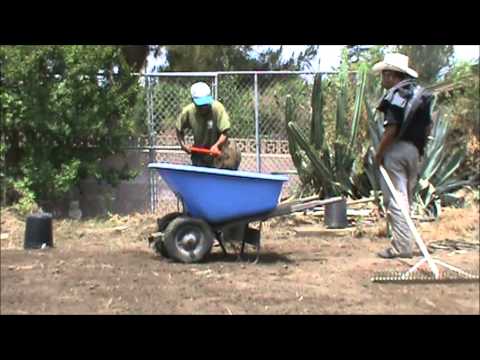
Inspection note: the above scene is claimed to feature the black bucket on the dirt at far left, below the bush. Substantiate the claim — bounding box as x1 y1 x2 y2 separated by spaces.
23 213 53 249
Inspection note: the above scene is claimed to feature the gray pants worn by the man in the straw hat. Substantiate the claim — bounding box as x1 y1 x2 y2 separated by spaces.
380 141 420 254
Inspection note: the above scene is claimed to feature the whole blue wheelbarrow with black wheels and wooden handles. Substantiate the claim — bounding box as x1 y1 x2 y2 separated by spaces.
148 163 342 263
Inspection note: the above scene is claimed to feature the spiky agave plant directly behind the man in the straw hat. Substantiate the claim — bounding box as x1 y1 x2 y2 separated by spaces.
365 97 472 217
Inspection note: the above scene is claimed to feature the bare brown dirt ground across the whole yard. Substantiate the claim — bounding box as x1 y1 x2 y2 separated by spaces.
0 205 480 315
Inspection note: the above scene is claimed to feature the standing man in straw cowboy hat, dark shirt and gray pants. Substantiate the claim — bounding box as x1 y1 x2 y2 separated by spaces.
373 53 432 259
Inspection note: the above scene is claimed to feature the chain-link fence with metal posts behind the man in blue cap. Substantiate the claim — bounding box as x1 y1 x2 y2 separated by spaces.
143 71 330 213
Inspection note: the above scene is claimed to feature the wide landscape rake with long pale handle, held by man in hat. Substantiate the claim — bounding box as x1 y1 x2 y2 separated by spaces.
371 165 479 283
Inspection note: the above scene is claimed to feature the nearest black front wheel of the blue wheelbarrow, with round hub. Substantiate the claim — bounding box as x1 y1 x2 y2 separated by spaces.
164 216 214 263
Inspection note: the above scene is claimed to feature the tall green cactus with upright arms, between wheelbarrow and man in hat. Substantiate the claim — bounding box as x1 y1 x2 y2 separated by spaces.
285 62 367 197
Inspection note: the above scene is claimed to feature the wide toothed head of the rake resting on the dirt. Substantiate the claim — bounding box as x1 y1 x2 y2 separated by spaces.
371 271 480 284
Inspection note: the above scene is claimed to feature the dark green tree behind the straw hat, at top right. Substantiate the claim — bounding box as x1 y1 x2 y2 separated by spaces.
396 45 453 85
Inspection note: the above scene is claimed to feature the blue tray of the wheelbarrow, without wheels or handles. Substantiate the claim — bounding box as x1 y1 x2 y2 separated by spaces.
148 163 288 224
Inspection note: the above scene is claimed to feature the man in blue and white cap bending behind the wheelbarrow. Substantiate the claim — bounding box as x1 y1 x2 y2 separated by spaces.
176 82 240 170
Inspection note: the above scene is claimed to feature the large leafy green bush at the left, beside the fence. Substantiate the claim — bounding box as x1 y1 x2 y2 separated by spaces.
0 46 138 208
